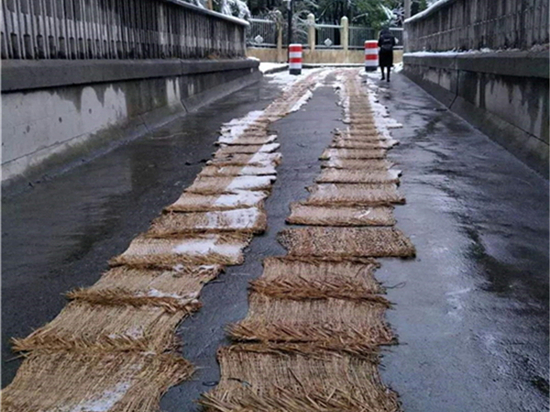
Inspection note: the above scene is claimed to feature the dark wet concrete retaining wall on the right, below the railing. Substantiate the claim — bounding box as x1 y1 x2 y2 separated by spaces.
403 52 550 178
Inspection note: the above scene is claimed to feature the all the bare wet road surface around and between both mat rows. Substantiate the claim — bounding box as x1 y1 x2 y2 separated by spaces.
2 71 549 412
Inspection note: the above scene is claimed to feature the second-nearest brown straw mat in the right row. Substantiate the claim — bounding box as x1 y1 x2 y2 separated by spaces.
229 293 394 350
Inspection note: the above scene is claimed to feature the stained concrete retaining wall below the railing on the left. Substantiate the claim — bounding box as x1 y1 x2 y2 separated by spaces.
2 59 261 182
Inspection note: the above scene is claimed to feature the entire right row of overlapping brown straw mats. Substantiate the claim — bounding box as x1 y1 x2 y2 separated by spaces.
205 72 415 412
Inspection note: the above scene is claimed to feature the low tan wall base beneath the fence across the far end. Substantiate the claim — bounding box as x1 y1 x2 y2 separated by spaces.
250 47 403 64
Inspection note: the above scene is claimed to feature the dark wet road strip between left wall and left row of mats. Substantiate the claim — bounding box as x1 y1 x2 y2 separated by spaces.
2 75 280 387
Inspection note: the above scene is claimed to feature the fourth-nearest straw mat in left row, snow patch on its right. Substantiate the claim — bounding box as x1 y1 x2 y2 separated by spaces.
110 233 252 269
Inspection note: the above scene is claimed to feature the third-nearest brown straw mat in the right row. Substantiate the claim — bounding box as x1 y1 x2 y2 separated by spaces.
250 258 386 302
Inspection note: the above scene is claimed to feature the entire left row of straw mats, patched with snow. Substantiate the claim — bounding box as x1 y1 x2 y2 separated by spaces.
2 69 328 412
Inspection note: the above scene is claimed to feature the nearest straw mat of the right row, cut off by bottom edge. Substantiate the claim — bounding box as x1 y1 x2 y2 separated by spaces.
201 345 399 412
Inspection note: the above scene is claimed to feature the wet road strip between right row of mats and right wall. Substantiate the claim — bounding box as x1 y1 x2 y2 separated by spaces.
377 76 549 412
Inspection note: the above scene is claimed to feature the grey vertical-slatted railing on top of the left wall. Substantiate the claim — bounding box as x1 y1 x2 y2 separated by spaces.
0 0 247 59
